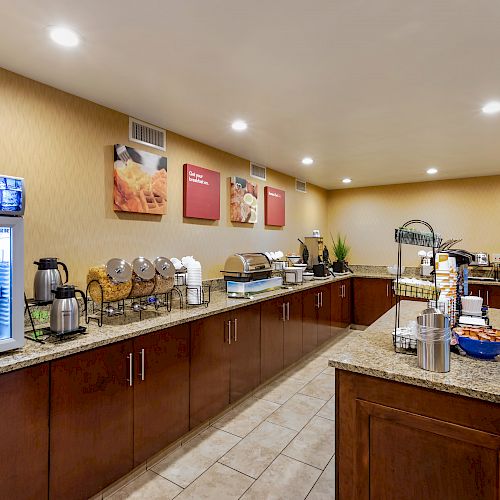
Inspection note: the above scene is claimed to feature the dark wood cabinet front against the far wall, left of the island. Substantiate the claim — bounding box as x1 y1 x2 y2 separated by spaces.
352 278 395 326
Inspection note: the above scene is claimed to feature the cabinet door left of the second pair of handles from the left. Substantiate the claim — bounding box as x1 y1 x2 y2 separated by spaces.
189 314 230 429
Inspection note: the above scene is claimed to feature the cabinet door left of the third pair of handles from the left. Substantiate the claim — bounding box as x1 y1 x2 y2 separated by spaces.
260 298 286 382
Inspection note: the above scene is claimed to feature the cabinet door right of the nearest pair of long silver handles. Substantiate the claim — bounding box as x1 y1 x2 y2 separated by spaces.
134 325 189 465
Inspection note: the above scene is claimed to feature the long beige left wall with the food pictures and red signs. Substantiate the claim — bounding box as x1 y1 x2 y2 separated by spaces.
0 69 327 294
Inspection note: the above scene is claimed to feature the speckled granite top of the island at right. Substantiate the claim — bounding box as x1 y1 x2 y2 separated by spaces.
329 300 500 403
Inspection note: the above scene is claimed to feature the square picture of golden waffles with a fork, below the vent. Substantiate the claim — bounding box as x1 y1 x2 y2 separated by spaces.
113 144 167 215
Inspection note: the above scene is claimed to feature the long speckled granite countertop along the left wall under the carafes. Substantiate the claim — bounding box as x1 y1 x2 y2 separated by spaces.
0 276 350 373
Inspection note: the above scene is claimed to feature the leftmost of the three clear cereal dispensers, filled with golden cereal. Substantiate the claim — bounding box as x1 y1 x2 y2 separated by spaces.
87 258 132 303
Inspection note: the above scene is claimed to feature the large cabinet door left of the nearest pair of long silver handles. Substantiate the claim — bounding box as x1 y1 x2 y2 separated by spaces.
50 340 134 499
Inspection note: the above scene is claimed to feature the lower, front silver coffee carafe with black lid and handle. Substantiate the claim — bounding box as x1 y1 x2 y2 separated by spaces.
50 285 87 334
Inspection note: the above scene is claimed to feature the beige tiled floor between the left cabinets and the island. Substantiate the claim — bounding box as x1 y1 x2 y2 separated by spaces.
105 331 357 500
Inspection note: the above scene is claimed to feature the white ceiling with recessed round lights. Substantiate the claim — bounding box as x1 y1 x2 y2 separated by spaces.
0 0 500 188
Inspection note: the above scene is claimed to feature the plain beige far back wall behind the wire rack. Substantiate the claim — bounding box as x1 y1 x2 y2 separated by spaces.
328 176 500 266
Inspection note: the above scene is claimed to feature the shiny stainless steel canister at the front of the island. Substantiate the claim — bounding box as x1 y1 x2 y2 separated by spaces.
417 311 451 373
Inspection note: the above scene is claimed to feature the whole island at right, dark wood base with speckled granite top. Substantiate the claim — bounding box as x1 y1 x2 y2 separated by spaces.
329 301 500 500
